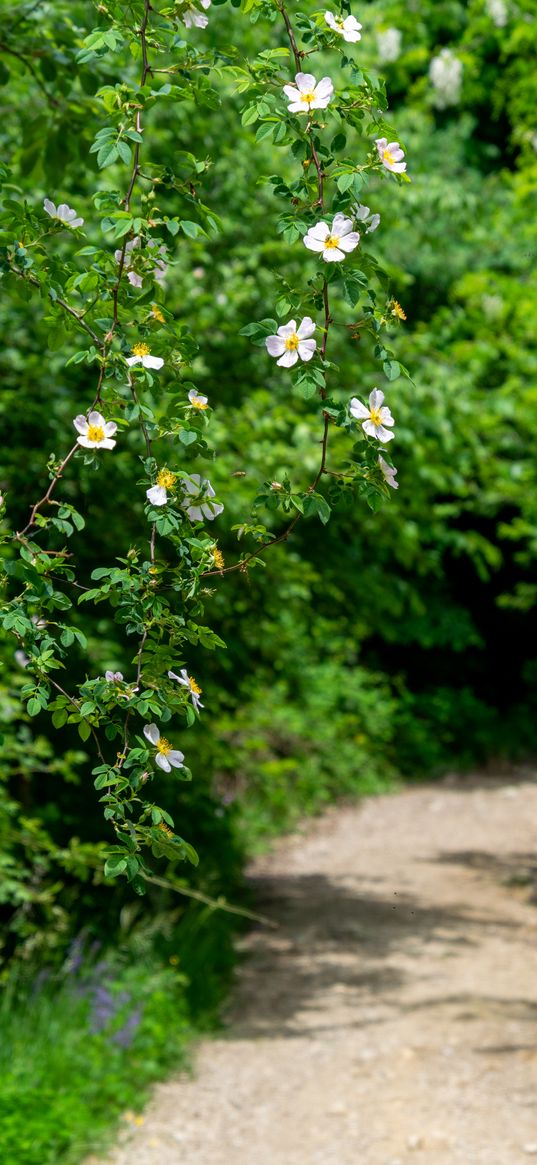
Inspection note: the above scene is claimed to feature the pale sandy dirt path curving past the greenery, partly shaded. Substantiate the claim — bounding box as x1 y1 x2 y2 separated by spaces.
101 772 537 1165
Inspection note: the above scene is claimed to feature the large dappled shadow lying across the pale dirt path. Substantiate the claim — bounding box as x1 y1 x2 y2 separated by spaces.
233 853 537 1038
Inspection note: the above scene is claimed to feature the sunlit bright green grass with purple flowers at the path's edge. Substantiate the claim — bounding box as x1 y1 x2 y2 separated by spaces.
0 962 189 1165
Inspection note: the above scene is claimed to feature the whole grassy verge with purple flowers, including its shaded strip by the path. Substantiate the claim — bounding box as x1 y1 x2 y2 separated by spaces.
0 909 234 1165
